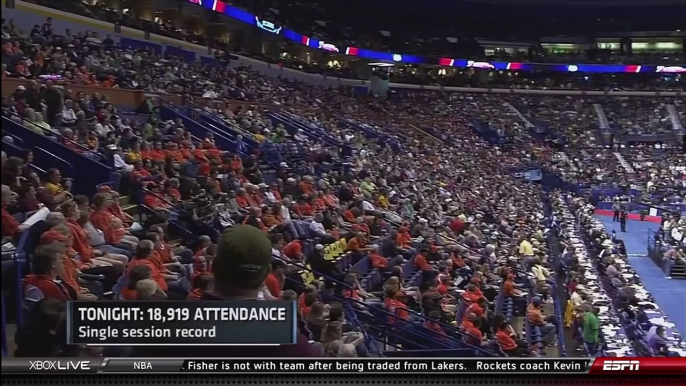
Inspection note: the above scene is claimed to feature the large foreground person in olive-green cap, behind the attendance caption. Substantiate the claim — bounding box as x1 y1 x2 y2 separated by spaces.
134 225 324 358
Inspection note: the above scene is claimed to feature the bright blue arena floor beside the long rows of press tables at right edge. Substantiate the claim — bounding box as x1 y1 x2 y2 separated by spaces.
595 215 686 339
